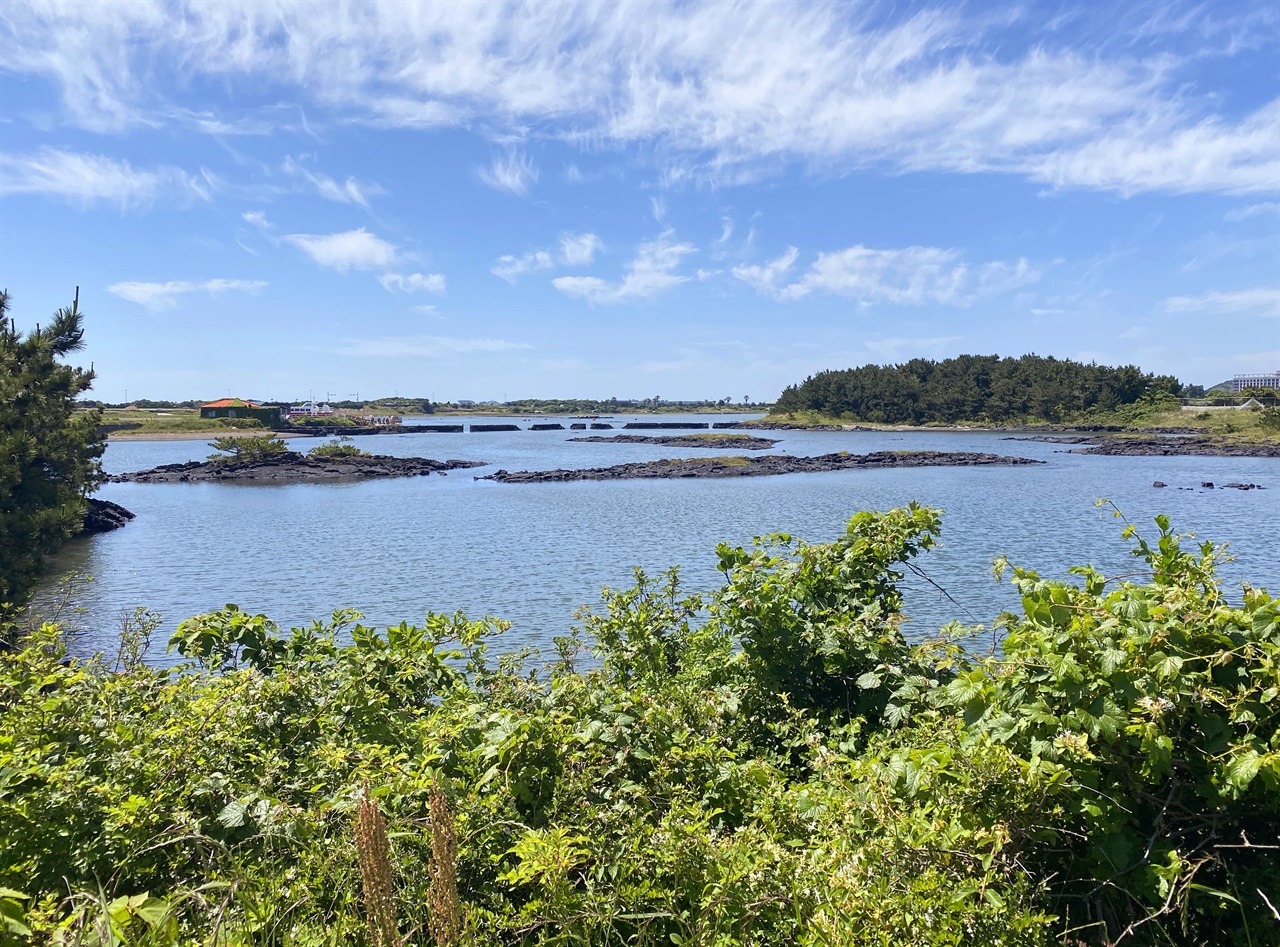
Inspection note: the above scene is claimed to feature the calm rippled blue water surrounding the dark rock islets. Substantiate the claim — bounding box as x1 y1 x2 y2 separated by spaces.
35 416 1280 660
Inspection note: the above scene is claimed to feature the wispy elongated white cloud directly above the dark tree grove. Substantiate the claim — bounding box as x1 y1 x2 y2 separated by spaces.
733 244 1039 306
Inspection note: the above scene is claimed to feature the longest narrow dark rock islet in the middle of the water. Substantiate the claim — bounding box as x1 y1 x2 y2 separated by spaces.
476 450 1043 484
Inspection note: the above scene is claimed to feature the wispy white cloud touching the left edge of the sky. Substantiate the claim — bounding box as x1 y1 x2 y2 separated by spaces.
0 148 212 211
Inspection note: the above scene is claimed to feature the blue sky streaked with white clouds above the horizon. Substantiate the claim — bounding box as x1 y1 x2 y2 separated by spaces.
0 0 1280 401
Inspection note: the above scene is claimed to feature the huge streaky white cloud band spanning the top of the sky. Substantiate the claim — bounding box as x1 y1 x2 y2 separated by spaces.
0 0 1280 193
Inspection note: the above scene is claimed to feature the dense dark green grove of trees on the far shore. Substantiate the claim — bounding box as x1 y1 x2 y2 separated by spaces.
774 354 1183 424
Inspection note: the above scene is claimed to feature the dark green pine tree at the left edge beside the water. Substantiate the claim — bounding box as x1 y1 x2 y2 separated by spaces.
0 287 106 609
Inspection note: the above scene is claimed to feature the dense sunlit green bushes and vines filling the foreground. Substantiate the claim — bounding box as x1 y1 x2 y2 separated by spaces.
0 507 1280 947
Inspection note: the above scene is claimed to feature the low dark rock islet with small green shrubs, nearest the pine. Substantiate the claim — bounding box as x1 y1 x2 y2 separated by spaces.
108 452 484 484
